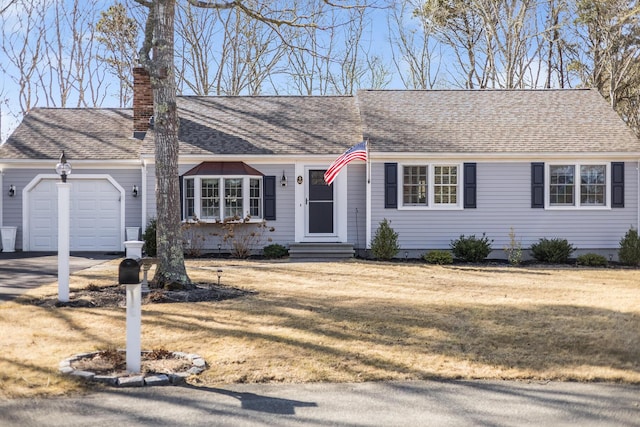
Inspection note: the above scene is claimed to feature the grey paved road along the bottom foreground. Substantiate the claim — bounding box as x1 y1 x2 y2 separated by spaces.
0 381 640 427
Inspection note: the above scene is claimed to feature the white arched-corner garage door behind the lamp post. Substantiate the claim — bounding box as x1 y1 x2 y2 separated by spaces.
29 179 122 251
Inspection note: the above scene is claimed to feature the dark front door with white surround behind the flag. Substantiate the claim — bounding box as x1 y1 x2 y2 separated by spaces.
307 169 333 234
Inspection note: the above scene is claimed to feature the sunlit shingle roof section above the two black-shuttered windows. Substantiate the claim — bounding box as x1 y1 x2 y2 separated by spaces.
358 89 640 153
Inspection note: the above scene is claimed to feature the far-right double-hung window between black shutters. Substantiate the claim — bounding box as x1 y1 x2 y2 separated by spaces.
548 163 610 208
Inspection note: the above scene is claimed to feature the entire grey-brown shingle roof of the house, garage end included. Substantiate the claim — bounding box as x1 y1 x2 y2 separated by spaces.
0 90 640 160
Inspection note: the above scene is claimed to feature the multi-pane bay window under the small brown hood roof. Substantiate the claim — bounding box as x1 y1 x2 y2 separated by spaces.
183 176 263 222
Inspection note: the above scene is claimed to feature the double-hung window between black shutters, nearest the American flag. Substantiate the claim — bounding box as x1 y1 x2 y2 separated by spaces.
400 164 461 209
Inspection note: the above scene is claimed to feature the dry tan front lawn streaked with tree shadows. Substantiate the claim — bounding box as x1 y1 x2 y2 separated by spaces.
0 260 640 398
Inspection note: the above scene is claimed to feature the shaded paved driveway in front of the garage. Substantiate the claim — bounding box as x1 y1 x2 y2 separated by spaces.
0 252 119 303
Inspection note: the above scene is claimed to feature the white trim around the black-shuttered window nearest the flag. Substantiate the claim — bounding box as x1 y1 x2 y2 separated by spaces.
397 162 464 211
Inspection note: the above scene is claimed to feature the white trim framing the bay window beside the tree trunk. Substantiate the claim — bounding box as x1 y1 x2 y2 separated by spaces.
182 175 264 224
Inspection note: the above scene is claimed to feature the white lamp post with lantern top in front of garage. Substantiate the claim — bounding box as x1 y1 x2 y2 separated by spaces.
56 151 71 302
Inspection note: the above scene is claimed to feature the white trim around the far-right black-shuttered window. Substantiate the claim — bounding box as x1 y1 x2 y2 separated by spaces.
544 160 612 211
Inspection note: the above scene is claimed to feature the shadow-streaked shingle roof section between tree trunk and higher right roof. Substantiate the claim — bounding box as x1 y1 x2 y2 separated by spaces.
178 96 362 155
